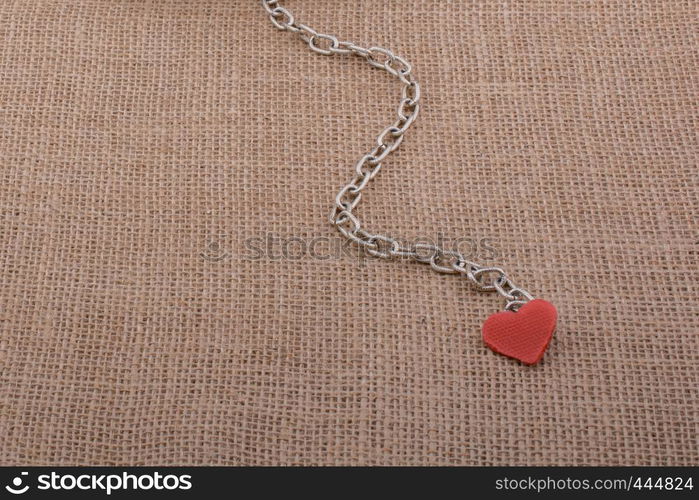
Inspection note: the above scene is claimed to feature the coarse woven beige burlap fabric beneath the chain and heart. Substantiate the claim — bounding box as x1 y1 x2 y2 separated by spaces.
0 0 699 465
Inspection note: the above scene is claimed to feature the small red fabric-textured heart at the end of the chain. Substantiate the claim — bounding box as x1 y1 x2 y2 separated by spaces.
483 299 558 365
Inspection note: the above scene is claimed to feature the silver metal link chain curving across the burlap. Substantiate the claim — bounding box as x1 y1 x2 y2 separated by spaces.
262 0 534 311
